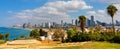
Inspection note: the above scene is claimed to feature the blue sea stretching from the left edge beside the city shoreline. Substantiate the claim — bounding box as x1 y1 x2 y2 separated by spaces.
0 27 31 40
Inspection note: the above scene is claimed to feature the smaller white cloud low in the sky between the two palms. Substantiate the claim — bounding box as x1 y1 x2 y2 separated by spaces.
88 10 111 23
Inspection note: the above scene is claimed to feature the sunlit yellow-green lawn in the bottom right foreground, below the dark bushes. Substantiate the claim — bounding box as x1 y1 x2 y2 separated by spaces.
54 42 120 49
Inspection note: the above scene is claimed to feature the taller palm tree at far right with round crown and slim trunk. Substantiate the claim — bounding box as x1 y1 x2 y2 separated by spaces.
107 5 118 33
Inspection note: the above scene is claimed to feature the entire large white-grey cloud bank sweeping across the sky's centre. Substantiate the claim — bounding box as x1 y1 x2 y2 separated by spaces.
13 0 92 23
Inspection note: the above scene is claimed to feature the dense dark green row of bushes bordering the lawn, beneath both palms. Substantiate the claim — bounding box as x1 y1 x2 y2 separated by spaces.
66 29 120 43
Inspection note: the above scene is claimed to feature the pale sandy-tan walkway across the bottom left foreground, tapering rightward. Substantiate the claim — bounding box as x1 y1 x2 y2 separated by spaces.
0 39 88 49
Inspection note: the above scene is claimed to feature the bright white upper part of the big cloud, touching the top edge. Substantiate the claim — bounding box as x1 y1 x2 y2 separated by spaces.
45 0 93 12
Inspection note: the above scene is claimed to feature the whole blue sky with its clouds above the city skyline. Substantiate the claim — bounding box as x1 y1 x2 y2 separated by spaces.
0 0 120 27
